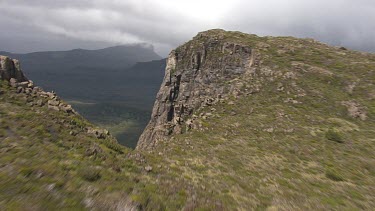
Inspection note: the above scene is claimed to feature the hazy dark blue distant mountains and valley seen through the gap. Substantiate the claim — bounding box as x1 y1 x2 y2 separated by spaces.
0 45 165 147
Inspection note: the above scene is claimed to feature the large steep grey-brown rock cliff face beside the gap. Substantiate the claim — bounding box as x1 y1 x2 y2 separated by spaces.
137 30 254 149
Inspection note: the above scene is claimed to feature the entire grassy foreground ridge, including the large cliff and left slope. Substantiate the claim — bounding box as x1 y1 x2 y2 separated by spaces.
0 30 375 210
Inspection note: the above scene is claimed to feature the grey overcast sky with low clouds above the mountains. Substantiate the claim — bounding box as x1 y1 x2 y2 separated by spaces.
0 0 375 56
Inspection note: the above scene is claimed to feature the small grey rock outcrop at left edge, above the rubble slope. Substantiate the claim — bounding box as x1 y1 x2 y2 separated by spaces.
0 56 27 82
